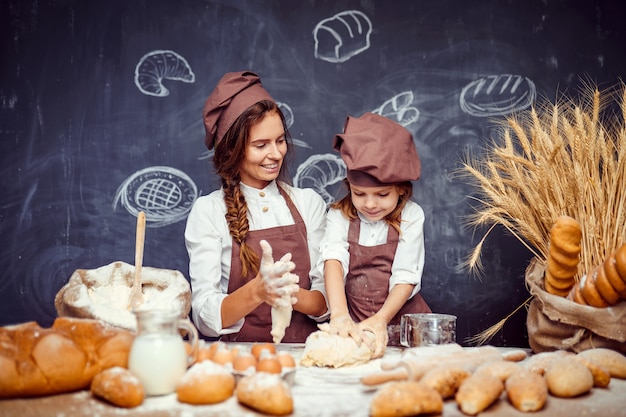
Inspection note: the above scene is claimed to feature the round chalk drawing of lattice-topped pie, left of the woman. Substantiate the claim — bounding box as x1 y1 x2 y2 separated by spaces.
113 166 198 227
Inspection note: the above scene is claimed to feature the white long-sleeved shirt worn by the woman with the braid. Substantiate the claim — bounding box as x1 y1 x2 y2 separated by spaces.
185 181 327 337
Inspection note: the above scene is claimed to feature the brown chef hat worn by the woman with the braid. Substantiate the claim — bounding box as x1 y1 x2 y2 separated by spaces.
202 71 274 150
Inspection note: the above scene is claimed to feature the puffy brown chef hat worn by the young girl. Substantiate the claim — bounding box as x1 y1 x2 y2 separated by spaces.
333 113 421 187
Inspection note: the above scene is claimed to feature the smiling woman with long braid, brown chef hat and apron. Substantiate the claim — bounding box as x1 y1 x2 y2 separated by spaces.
185 71 327 343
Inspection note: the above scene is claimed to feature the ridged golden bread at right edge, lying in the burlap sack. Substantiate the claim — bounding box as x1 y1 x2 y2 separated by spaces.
568 244 626 307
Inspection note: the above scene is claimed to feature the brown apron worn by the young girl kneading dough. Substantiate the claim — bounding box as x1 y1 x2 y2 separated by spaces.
346 218 431 332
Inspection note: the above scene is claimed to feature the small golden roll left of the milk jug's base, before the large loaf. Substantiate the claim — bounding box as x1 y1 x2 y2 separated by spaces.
90 366 146 408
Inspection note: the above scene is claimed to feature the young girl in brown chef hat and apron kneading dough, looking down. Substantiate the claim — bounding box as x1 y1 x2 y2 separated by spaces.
320 113 430 357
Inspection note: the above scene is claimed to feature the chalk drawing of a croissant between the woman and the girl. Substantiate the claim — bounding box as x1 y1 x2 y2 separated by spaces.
293 154 347 203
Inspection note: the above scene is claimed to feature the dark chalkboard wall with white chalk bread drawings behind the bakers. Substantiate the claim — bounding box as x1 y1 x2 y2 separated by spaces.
0 0 626 346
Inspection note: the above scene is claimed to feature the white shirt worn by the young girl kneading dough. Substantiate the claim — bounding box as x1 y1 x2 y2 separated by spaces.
318 201 425 297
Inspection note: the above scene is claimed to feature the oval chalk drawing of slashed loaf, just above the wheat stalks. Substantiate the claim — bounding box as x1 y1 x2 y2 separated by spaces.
459 74 537 117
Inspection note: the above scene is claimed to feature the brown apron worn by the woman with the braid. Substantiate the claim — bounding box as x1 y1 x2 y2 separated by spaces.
221 187 317 343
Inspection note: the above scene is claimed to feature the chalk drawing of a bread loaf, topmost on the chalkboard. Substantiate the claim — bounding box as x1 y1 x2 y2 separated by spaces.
313 10 372 63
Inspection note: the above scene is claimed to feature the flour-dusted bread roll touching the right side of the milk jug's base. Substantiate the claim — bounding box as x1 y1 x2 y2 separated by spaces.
176 361 235 404
